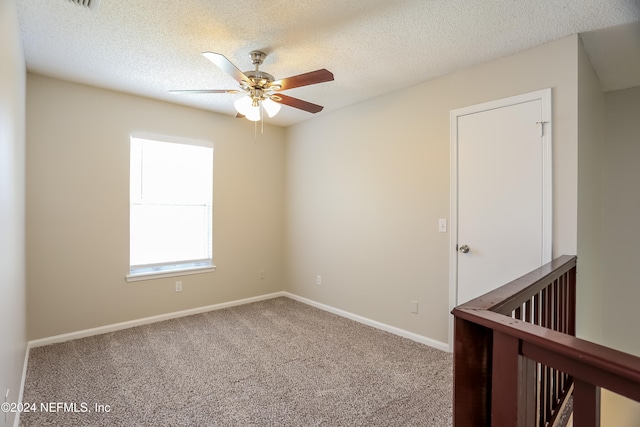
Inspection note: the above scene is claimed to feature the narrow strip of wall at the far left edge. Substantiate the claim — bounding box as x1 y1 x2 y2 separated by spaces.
0 0 27 425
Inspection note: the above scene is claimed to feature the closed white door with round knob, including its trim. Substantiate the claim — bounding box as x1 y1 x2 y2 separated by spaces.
451 90 551 334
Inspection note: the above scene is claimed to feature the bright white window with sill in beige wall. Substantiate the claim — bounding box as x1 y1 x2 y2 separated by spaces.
127 135 215 281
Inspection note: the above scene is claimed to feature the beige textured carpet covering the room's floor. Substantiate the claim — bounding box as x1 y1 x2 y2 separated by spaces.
20 298 452 427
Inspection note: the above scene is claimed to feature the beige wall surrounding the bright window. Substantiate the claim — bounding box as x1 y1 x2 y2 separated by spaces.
26 74 284 339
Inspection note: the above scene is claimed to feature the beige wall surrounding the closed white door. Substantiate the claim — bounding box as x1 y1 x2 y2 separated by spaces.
285 36 578 342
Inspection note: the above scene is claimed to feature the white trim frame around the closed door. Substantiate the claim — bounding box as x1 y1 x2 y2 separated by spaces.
449 89 553 352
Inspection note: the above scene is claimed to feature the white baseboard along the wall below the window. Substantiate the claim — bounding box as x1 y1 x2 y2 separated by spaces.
28 292 285 348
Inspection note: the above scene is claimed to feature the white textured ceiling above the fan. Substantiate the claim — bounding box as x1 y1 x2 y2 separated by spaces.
17 0 640 126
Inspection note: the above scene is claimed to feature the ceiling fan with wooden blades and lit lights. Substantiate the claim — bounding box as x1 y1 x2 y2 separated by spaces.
170 50 333 121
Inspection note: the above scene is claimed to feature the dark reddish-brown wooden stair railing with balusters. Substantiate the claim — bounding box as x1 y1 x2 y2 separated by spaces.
452 255 640 427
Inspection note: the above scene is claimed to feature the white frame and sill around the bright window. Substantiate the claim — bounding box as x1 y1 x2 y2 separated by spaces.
125 132 216 282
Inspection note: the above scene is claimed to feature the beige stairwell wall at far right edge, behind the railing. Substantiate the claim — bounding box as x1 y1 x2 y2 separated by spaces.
602 87 640 427
